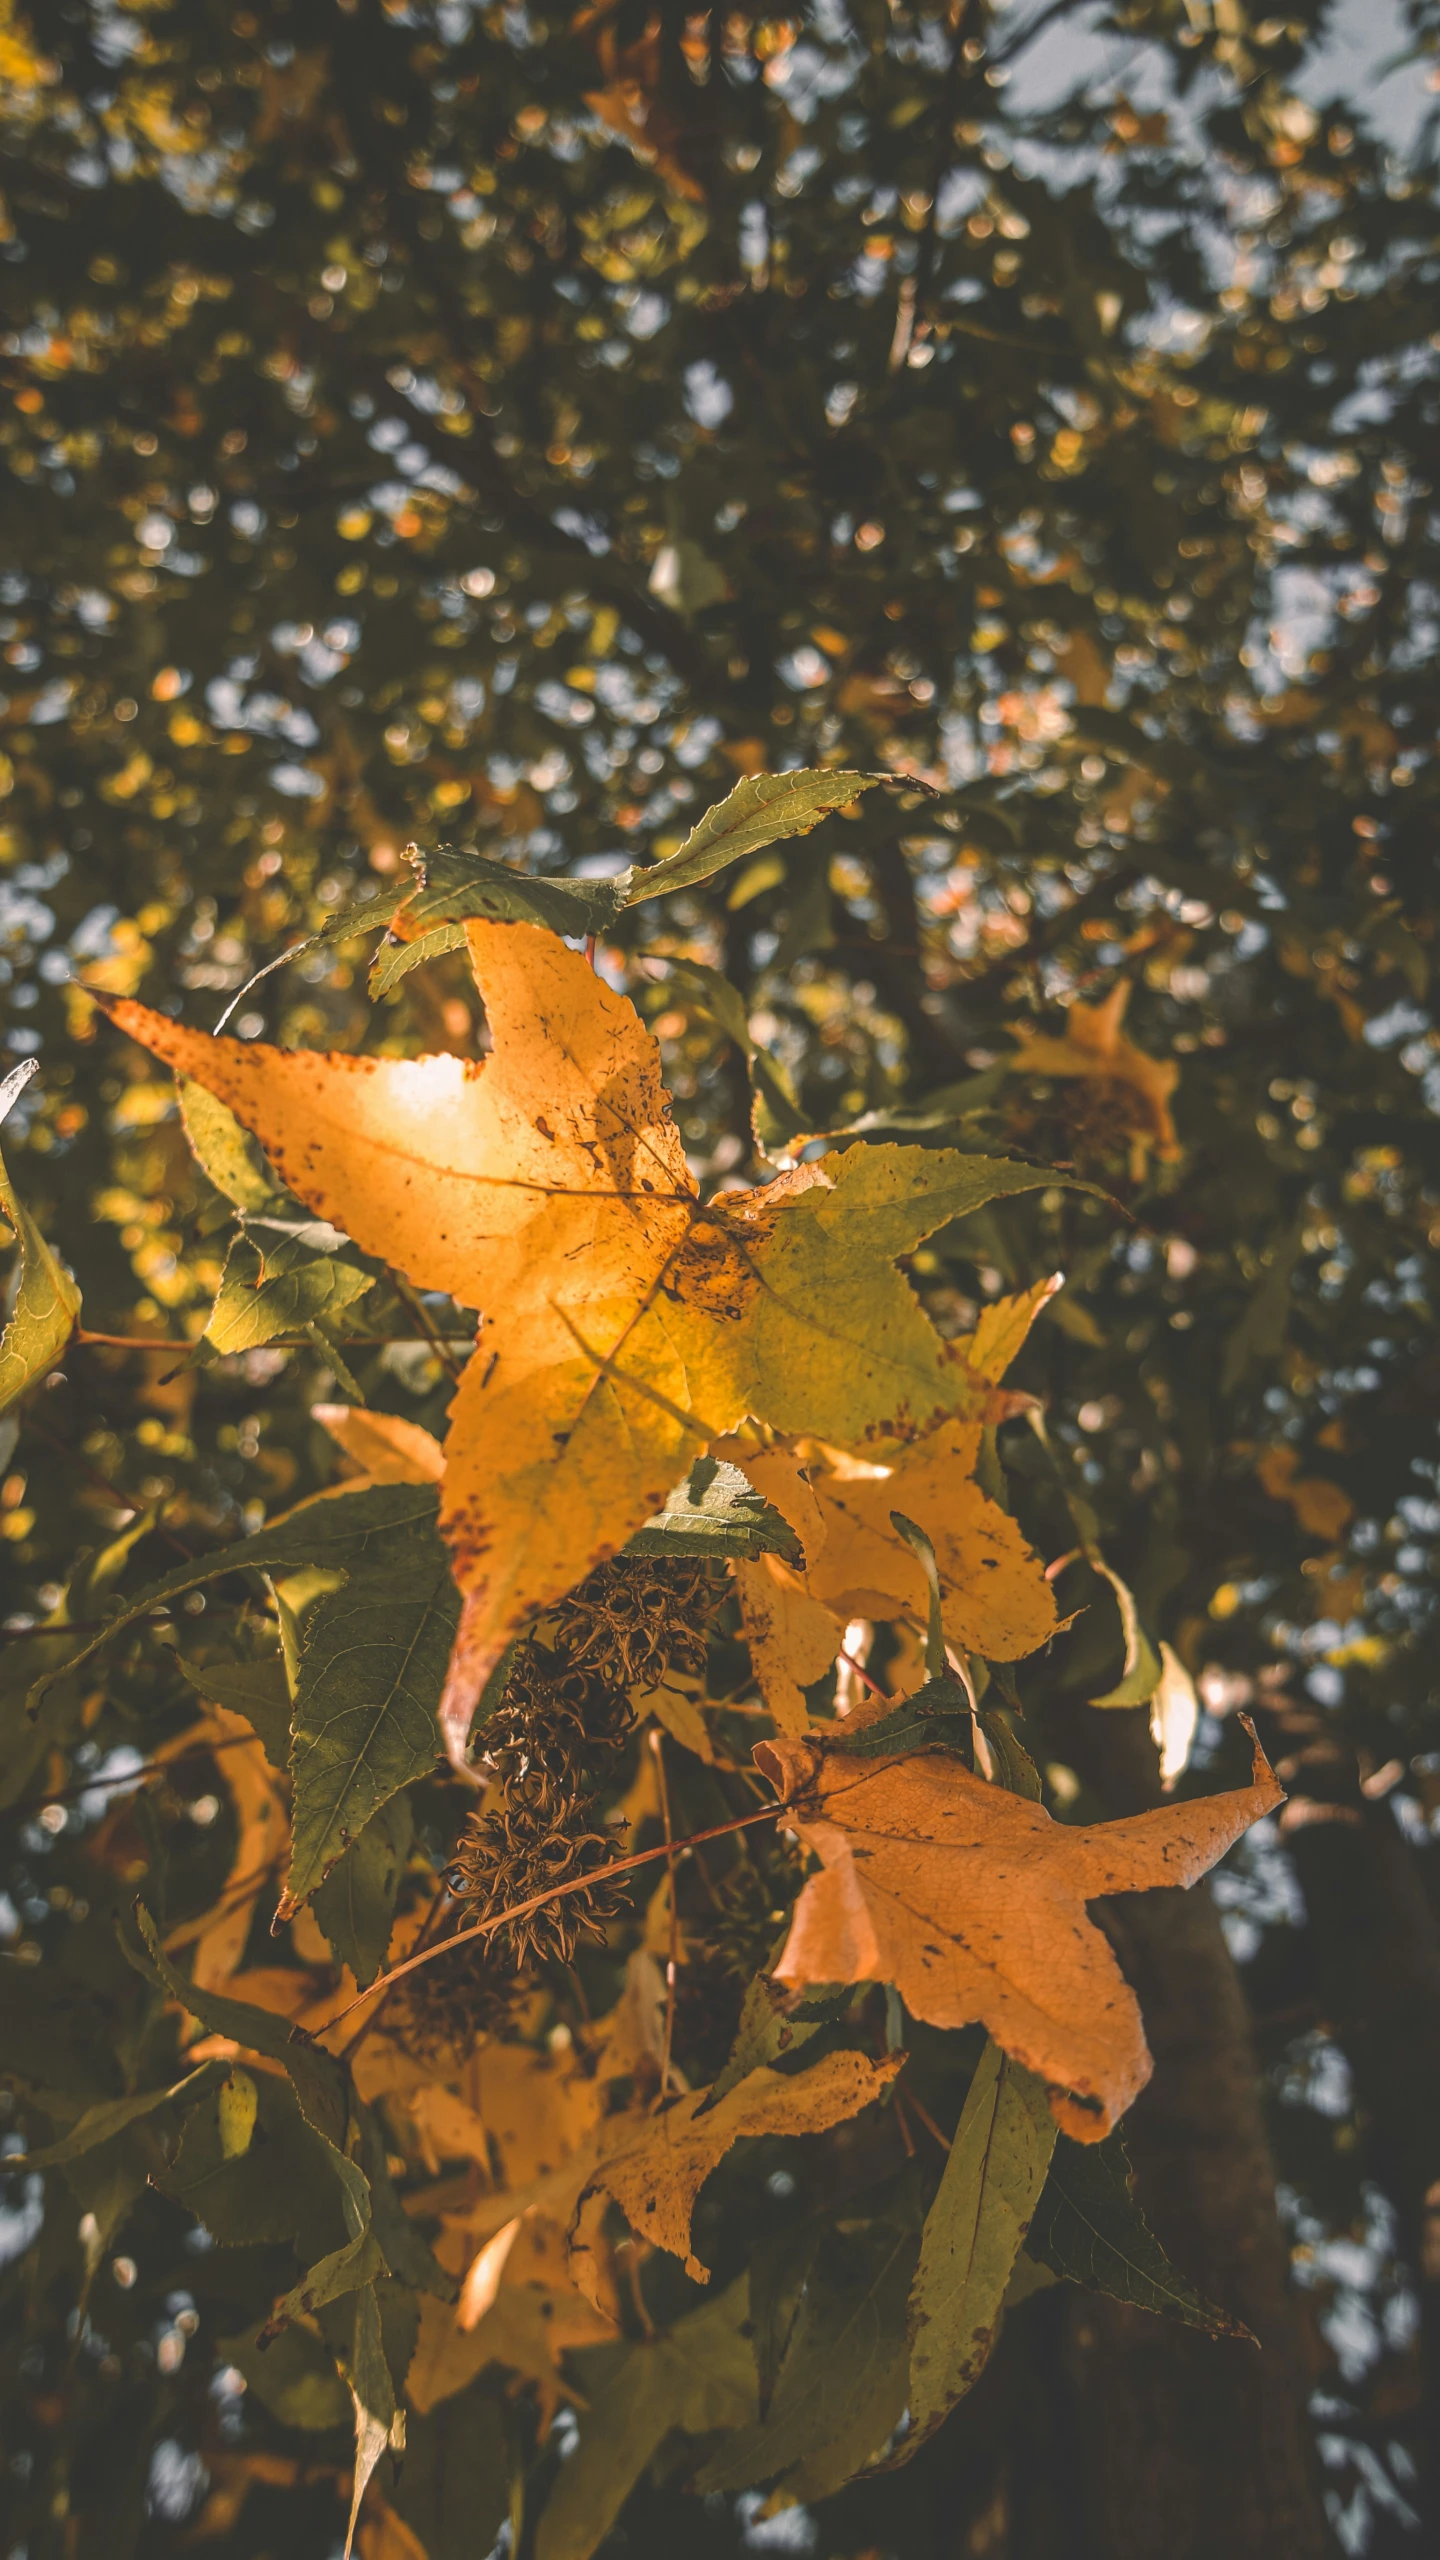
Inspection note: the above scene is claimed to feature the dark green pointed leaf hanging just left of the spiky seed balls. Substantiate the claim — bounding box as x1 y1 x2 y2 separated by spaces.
282 1510 459 1912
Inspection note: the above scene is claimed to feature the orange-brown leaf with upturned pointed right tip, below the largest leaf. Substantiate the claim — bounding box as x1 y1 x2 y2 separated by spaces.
756 1733 1284 2143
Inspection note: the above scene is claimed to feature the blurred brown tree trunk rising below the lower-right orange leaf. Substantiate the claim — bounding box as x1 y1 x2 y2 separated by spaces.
1035 1708 1332 2560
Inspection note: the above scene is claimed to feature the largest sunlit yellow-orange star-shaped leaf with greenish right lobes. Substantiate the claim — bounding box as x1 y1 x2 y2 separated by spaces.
113 924 1045 1761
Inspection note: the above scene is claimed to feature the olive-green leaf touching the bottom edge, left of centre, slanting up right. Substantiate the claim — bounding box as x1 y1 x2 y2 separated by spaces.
536 2278 756 2560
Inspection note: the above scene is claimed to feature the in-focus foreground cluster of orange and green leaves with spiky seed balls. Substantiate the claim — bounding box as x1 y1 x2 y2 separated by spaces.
5 773 1279 2560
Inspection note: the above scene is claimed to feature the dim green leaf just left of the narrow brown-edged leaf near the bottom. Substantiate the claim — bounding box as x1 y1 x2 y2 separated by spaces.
697 2217 917 2499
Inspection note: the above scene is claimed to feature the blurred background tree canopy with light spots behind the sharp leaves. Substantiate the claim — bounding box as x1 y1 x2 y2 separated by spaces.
0 0 1440 2560
